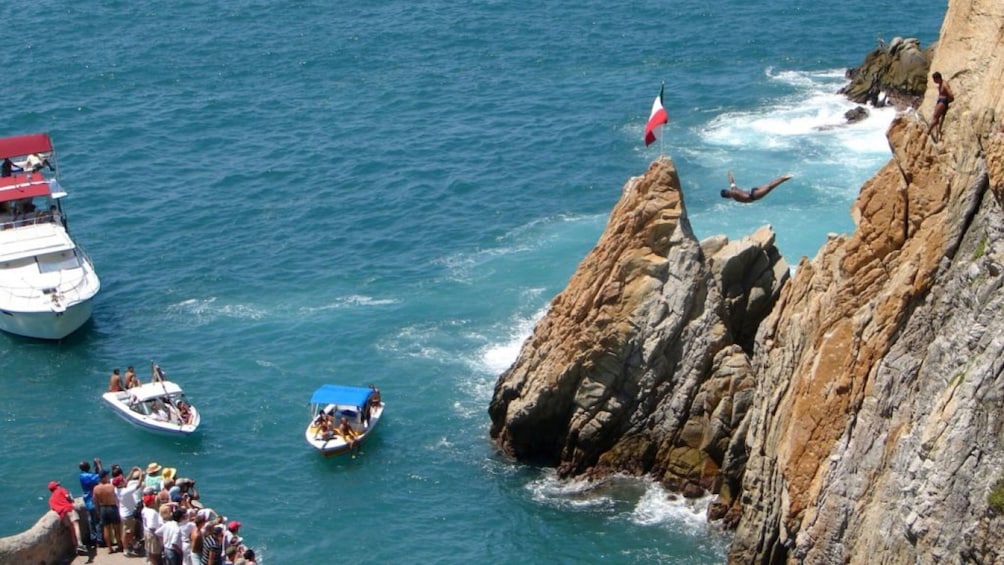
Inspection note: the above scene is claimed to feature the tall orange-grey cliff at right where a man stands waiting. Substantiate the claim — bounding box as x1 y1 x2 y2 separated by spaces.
731 0 1004 563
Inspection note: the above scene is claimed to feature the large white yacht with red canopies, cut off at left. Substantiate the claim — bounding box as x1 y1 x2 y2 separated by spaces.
0 133 101 339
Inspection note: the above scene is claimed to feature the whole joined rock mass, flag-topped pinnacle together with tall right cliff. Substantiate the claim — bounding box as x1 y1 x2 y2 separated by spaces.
490 0 1004 564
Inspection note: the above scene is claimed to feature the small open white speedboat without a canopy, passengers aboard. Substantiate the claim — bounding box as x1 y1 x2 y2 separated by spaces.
101 380 202 436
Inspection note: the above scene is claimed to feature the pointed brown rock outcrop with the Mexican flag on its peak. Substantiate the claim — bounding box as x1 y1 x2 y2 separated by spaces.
489 159 789 512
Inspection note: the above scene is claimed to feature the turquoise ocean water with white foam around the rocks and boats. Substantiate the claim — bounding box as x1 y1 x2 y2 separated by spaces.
0 0 946 563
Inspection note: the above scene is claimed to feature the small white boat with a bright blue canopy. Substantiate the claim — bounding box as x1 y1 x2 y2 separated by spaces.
303 384 384 456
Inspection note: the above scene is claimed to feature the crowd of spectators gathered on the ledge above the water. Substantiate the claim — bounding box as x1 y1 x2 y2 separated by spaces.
49 458 257 565
